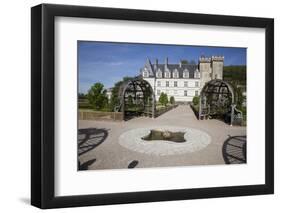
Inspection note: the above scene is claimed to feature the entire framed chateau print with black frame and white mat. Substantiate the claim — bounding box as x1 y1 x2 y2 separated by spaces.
31 4 274 208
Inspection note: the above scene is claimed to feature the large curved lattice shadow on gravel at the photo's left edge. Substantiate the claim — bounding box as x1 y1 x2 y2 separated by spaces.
78 128 108 156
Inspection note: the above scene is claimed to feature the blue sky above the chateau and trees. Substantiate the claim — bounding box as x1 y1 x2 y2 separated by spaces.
78 41 246 93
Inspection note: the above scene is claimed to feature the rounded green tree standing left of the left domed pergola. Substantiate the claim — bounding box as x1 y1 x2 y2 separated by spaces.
87 83 108 110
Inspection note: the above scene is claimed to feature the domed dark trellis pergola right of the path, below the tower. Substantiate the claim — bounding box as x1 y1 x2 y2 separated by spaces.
199 79 242 125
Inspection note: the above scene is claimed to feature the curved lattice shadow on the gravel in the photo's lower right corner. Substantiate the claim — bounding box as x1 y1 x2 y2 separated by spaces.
222 136 247 164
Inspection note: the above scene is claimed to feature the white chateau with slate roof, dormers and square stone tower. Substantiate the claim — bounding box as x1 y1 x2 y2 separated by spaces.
140 56 224 102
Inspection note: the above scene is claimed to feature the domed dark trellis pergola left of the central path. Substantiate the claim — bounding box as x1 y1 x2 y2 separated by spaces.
116 77 155 120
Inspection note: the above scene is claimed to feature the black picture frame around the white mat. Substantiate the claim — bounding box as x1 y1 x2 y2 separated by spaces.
31 4 274 209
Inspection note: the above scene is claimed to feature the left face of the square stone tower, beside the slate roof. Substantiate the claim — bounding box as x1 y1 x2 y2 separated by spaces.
199 56 212 88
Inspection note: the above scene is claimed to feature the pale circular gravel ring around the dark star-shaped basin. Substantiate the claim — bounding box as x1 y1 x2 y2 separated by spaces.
119 126 211 156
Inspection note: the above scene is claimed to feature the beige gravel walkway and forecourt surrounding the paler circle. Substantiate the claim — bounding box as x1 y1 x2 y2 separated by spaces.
78 105 246 169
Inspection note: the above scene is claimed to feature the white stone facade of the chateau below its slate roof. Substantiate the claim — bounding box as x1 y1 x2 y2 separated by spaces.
144 78 201 102
